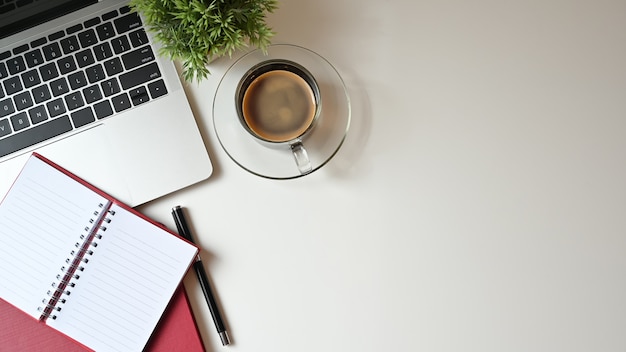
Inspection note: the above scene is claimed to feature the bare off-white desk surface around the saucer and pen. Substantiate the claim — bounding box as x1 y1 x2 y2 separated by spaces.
140 0 626 352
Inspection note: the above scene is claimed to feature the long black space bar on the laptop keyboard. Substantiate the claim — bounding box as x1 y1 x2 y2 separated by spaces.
0 115 72 157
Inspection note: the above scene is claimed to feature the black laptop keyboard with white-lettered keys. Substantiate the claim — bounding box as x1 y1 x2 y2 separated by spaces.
0 5 167 157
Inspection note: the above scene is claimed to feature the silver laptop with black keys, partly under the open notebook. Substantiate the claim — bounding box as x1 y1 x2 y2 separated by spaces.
0 0 213 206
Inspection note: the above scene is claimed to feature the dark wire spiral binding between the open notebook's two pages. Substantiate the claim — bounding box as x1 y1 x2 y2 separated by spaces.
37 203 115 320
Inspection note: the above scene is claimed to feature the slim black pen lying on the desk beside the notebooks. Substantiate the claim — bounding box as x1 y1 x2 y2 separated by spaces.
172 205 230 346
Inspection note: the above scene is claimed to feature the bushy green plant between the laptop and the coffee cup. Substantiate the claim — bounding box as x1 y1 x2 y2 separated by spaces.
130 0 278 81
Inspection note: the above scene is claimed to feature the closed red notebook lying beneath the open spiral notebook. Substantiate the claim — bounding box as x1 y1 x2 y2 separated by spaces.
0 284 205 352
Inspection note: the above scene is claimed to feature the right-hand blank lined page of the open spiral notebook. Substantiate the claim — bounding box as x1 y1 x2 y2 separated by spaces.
48 204 197 352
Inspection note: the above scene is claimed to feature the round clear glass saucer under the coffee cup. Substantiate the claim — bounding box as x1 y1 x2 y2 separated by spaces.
213 44 351 179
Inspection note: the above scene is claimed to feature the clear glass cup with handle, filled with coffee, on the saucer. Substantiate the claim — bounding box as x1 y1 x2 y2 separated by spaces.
235 59 322 175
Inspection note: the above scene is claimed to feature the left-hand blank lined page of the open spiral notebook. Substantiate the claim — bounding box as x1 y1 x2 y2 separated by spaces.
0 156 106 319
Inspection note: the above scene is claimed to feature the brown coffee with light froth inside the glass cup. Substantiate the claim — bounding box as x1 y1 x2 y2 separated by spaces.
241 69 317 142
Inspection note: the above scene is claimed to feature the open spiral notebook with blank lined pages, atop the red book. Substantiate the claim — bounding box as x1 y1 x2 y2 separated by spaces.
0 154 198 351
